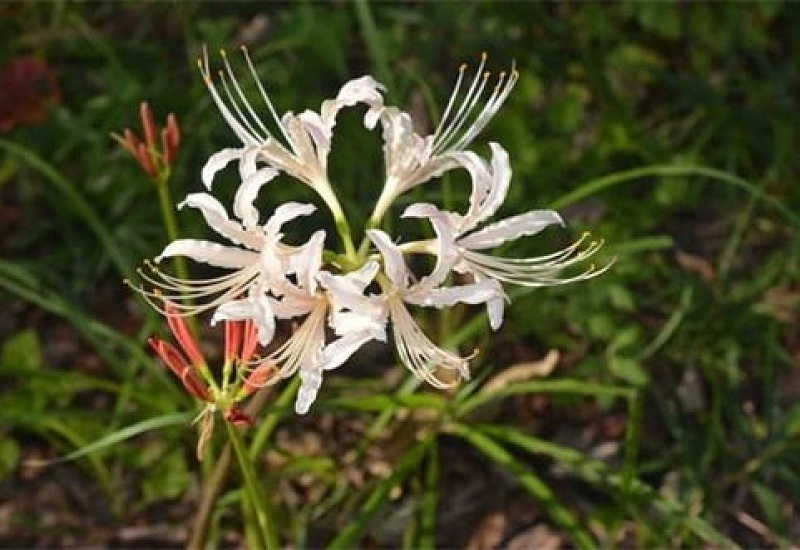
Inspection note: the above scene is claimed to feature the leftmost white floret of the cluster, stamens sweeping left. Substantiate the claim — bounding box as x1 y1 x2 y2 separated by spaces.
139 186 316 345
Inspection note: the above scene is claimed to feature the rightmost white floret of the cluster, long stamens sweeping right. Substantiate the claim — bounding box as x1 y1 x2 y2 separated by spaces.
403 143 605 330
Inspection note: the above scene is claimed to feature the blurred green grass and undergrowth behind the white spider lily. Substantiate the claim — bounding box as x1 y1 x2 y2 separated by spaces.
0 1 800 548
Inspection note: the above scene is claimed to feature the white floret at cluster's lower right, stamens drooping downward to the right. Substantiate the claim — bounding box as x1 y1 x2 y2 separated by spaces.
367 229 497 388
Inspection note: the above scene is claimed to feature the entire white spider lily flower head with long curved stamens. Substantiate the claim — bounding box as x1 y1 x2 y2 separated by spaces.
142 52 602 413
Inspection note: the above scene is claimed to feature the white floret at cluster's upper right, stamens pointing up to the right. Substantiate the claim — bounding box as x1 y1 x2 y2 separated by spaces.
365 54 519 226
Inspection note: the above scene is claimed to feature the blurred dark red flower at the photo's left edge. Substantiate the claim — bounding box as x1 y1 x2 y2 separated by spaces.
0 57 61 132
